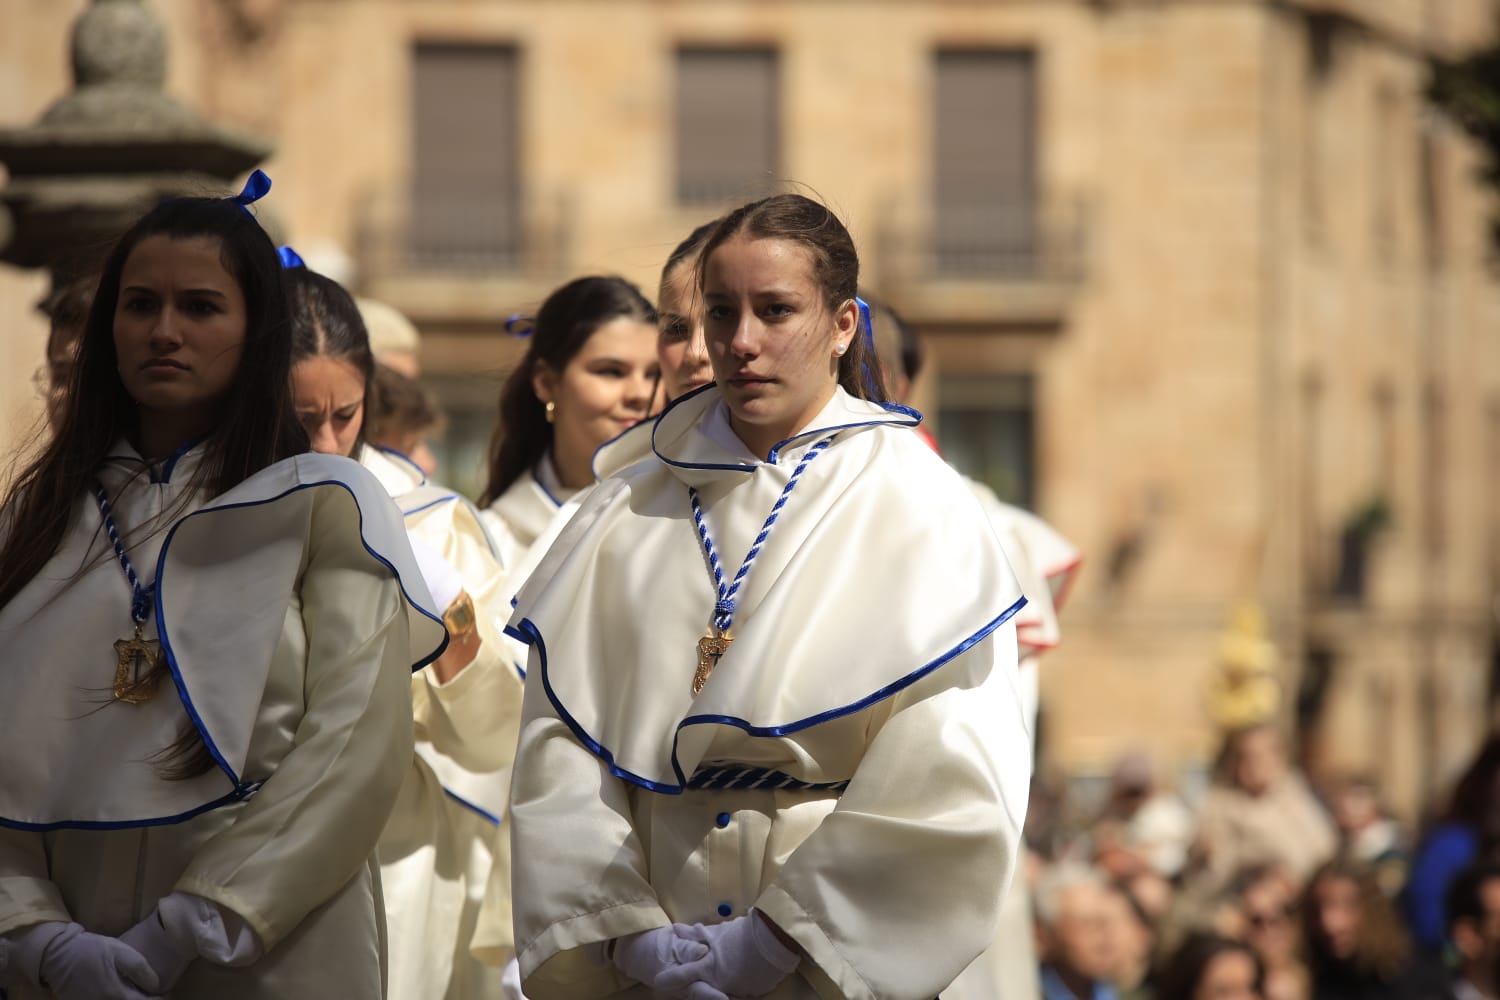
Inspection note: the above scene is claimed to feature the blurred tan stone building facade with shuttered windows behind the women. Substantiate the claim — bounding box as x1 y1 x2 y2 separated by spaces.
0 0 1500 816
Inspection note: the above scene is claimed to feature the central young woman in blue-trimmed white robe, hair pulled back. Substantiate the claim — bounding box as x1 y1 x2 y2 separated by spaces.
510 195 1031 1000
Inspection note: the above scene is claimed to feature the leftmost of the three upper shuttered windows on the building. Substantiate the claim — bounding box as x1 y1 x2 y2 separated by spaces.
408 42 522 268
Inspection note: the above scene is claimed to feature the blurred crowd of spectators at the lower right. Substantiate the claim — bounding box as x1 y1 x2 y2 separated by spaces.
1025 726 1500 1000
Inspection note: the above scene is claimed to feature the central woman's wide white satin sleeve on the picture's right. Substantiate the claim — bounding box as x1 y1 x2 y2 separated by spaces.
755 622 1031 1000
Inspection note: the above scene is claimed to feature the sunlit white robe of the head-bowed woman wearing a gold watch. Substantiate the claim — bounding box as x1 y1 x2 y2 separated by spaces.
360 447 522 1000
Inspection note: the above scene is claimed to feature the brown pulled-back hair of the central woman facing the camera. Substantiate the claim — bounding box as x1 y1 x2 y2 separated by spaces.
698 195 890 403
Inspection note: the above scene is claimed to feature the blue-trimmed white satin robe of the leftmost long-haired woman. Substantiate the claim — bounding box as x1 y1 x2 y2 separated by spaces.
0 445 446 1000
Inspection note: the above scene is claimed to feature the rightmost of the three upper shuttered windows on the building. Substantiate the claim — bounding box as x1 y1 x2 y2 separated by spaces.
933 48 1038 277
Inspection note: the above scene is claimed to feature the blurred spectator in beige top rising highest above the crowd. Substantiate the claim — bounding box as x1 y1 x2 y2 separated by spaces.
1199 723 1338 889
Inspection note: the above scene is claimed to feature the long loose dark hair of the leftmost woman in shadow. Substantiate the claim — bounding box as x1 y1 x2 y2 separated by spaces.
0 191 308 780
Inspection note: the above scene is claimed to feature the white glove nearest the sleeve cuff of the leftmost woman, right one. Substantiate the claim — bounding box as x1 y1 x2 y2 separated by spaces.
120 892 263 991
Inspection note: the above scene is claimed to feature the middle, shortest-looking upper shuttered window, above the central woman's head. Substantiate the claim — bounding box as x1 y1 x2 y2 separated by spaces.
677 46 782 205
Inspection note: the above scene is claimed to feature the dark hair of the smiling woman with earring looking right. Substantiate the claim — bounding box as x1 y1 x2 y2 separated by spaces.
479 276 657 507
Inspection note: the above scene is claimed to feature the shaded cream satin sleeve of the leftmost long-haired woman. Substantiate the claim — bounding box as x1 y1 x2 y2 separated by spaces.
176 498 416 951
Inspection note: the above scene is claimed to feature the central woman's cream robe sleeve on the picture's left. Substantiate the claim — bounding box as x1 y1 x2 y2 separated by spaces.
510 677 672 1000
